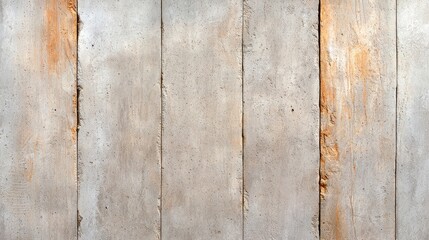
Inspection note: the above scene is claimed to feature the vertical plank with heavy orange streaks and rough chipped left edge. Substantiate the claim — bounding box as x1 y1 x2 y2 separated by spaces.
320 0 396 239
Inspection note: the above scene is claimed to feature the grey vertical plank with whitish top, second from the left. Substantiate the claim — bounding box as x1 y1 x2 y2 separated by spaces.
79 0 161 239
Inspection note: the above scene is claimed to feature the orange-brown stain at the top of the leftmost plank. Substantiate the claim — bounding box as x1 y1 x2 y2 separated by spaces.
44 0 77 73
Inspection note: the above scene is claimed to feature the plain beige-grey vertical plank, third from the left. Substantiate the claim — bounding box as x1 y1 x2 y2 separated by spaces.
162 0 242 239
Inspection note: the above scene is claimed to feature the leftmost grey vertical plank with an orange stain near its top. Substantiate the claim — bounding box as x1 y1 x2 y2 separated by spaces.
0 0 77 239
